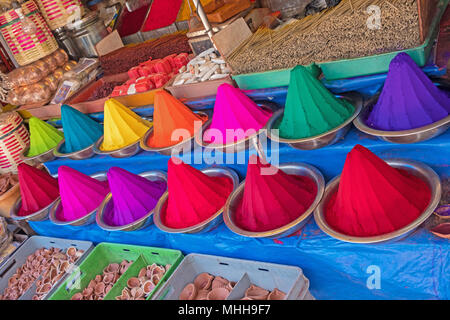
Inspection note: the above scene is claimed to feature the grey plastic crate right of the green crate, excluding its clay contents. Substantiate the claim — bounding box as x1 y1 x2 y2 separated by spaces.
153 253 308 300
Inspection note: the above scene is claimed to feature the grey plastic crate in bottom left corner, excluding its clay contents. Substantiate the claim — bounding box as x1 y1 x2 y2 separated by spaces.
0 236 93 300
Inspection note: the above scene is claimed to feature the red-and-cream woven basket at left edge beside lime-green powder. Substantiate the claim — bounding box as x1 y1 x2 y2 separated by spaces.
0 111 30 173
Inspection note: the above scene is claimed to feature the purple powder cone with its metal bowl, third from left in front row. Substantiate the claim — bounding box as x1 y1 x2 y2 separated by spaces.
97 167 167 231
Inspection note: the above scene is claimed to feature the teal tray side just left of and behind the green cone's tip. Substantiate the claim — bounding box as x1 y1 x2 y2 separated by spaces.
233 63 321 90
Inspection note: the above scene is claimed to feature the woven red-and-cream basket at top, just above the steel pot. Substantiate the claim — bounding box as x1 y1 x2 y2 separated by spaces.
36 0 84 30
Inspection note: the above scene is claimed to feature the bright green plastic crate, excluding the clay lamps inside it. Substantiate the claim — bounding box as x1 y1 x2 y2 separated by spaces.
49 242 183 300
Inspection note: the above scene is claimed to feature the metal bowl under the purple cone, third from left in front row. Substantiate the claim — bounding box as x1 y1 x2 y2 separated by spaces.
95 170 167 231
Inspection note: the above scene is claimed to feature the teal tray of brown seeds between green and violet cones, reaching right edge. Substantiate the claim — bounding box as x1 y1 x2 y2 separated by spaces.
317 0 449 80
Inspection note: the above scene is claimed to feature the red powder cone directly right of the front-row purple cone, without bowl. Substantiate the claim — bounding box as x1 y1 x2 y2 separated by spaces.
162 159 233 229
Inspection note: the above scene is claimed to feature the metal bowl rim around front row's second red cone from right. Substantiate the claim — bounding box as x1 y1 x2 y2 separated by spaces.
223 162 325 238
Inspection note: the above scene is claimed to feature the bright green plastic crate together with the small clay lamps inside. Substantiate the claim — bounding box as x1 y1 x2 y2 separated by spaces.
49 243 183 300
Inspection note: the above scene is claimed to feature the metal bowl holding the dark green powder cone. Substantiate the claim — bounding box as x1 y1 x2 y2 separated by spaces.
267 93 362 150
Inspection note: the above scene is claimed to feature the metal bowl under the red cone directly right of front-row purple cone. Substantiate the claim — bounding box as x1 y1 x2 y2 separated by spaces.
153 167 239 233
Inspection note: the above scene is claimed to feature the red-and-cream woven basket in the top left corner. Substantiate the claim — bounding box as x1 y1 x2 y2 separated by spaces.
0 1 58 66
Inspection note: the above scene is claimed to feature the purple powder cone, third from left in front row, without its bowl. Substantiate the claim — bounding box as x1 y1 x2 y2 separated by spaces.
104 167 167 226
